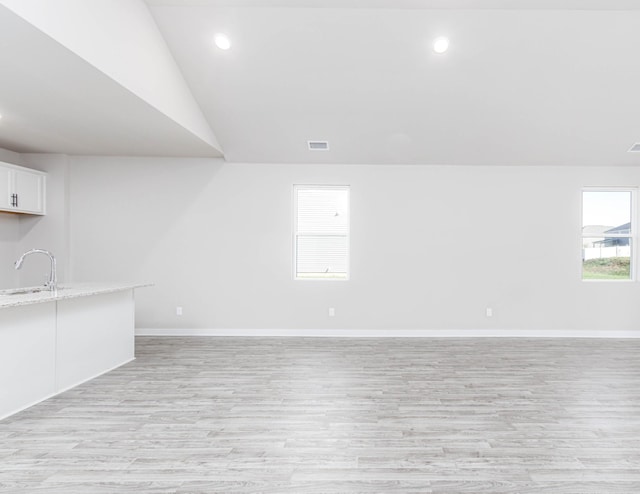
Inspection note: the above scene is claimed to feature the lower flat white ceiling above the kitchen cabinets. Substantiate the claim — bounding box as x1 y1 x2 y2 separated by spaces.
0 6 220 157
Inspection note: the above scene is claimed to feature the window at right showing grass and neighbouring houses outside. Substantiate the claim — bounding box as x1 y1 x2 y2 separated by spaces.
582 188 636 280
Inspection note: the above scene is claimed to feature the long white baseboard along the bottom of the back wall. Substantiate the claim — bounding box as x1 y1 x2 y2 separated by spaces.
136 328 640 338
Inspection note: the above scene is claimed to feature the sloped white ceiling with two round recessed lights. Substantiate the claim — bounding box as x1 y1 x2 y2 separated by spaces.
151 1 640 165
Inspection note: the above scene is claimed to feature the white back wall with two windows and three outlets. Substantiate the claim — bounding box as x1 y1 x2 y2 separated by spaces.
70 157 640 330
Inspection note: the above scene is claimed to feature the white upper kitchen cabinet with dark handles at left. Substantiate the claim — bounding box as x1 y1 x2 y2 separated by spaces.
0 162 47 215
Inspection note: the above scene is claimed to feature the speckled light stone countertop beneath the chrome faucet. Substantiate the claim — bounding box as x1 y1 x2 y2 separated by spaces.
0 283 153 309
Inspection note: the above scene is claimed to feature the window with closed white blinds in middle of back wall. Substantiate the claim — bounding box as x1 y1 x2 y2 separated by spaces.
293 185 349 280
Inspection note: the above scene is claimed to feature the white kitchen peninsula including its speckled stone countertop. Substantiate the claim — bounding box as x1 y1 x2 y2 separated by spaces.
0 283 150 419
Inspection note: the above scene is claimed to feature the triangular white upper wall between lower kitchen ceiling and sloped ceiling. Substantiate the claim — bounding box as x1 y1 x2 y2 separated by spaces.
0 0 220 150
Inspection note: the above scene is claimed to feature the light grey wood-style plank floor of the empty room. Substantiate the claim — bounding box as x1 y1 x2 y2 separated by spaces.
0 337 640 494
